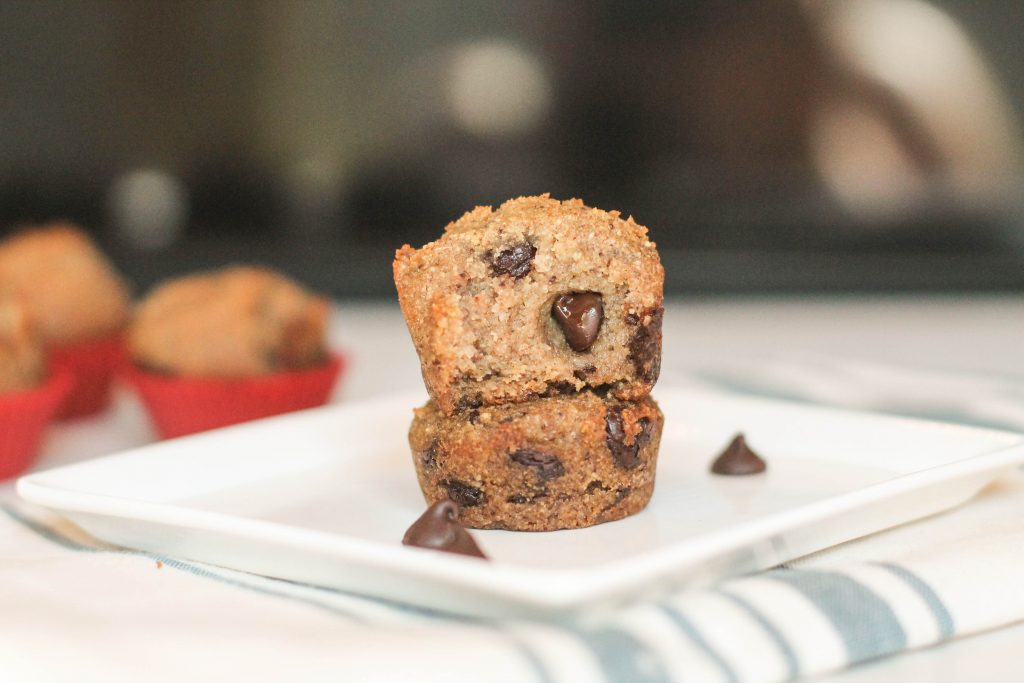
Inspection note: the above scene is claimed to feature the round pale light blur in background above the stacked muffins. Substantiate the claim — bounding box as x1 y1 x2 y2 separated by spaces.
446 40 552 137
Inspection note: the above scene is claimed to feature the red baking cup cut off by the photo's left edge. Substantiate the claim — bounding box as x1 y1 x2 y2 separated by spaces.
0 370 74 479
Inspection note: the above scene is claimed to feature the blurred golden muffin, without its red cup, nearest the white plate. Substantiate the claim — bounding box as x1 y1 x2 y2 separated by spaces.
128 266 329 378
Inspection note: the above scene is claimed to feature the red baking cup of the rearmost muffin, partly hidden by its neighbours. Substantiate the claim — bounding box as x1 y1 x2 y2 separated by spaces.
50 333 125 419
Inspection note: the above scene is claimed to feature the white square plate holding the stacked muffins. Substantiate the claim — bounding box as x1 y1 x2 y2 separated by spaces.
18 388 1024 615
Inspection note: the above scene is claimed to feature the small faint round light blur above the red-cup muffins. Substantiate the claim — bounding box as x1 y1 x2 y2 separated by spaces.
108 169 188 251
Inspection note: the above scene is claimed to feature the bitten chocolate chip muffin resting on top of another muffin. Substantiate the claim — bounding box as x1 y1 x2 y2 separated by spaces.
394 195 665 415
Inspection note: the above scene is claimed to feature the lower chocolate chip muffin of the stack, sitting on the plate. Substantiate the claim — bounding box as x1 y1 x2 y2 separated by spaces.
409 392 665 531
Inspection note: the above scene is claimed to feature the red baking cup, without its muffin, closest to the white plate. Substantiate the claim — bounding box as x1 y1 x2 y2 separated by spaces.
126 354 345 438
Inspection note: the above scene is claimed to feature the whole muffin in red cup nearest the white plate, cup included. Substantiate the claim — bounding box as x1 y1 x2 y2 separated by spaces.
126 266 344 438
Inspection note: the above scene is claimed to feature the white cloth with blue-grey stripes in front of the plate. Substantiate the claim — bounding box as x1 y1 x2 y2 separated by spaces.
0 473 1024 683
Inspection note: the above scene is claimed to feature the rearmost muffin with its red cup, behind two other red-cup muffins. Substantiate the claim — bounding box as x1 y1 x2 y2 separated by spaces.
0 223 131 418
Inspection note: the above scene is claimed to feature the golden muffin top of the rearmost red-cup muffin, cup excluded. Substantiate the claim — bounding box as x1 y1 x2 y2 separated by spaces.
0 223 130 345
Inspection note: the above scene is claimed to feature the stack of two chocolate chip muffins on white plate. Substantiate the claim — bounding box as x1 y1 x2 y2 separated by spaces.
394 196 665 530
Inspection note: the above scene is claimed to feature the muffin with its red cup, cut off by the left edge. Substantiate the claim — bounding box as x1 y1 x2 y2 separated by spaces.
0 297 71 479
